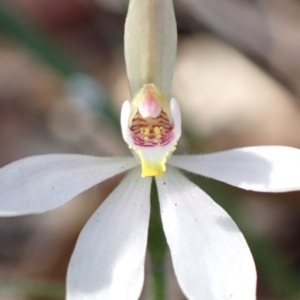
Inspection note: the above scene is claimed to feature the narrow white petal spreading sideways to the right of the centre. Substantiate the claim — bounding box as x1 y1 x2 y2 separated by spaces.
169 146 300 192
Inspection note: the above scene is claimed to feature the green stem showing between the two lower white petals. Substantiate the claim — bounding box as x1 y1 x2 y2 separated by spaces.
148 180 167 300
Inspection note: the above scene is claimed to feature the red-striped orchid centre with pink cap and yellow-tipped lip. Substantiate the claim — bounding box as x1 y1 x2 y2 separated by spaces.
121 84 181 177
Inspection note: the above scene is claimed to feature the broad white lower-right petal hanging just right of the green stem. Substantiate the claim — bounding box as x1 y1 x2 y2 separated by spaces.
156 167 256 300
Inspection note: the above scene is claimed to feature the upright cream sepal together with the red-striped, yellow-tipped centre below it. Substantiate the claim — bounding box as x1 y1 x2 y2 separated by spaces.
121 0 181 177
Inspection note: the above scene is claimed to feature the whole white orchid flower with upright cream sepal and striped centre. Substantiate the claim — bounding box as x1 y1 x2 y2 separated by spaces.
0 0 300 300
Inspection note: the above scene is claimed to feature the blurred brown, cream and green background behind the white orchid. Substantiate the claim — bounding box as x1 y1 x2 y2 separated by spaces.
0 0 300 300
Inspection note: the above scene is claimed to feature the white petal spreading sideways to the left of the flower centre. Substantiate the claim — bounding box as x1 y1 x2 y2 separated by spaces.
0 154 137 216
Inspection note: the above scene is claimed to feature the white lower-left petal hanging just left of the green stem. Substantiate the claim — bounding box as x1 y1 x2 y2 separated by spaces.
67 169 151 300
